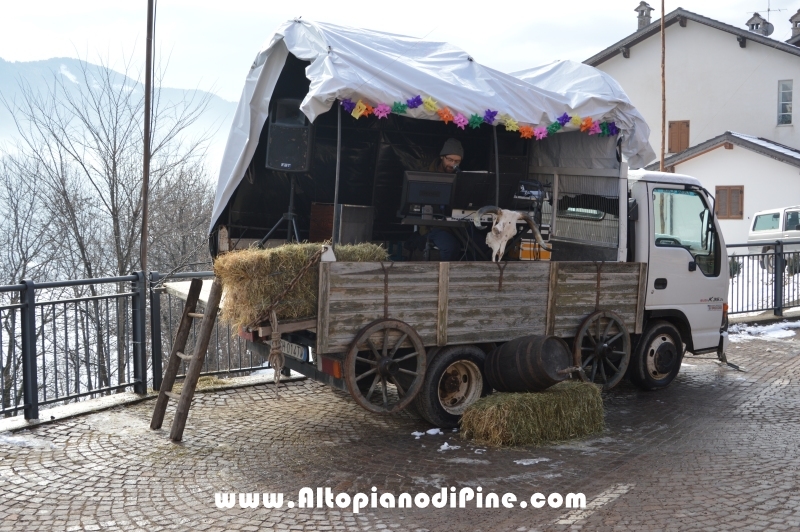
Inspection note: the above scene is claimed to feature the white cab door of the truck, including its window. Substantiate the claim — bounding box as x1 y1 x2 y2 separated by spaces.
645 183 728 350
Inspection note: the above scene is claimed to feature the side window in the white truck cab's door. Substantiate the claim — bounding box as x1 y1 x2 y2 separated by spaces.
653 188 720 276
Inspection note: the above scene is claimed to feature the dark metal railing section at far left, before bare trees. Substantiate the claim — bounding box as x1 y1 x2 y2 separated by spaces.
0 272 147 419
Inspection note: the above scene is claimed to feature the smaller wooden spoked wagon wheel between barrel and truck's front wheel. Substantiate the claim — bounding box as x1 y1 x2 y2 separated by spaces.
574 310 631 390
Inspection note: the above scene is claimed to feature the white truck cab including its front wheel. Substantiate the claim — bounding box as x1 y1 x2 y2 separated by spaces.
628 170 729 389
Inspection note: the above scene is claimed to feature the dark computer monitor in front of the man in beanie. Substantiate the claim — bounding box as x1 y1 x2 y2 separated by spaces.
398 171 456 218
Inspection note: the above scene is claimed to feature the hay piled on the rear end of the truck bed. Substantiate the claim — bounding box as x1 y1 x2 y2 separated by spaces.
214 243 388 330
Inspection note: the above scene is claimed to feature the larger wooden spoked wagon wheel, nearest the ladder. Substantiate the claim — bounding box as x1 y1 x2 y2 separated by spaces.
344 319 426 414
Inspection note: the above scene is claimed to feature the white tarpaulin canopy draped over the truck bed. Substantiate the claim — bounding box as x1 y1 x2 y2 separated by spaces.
211 20 655 229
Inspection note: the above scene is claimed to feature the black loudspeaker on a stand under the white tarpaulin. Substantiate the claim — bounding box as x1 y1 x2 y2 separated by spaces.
267 99 311 172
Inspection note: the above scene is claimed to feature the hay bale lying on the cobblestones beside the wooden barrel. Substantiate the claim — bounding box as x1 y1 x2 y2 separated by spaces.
461 381 604 446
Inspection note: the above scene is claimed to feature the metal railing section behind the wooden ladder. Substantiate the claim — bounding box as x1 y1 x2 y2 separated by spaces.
150 271 268 390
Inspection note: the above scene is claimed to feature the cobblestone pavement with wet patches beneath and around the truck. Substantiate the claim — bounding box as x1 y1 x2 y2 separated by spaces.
0 338 800 532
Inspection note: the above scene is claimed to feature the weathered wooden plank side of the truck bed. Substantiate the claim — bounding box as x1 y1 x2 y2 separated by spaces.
317 261 646 353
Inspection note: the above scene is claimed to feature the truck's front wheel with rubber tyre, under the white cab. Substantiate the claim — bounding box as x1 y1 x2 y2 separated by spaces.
628 321 683 390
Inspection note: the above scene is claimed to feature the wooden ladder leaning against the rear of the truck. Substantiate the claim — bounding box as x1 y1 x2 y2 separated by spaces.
150 279 222 442
